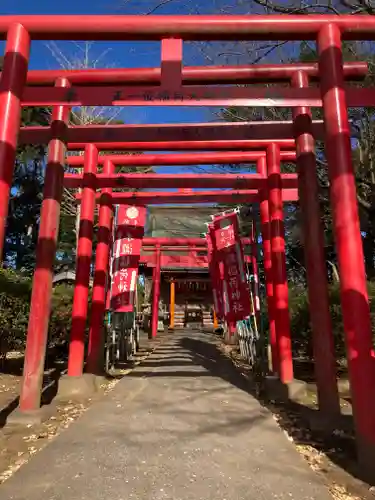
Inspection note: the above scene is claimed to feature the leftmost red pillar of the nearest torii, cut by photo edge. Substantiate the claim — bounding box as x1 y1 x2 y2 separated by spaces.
0 24 30 260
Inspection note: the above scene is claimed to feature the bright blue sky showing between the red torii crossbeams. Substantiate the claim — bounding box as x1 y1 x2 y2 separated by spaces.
1 0 274 178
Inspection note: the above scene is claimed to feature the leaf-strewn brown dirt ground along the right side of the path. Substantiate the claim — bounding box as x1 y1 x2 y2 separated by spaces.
221 344 375 500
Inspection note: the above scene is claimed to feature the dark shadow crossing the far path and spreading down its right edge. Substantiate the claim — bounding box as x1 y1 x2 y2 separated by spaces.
136 334 375 494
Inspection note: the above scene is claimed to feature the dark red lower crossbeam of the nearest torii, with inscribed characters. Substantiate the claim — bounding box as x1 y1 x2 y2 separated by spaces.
21 85 375 108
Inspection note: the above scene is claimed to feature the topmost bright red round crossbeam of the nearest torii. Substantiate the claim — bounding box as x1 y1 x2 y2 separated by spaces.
0 14 375 41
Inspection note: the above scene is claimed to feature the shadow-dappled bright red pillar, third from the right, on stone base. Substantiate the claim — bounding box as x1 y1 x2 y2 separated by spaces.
267 144 293 384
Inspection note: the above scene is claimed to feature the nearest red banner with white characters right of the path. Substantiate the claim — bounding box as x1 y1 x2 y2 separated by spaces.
213 212 251 322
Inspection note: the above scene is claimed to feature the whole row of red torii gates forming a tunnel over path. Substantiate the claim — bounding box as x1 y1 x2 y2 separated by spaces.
0 15 375 476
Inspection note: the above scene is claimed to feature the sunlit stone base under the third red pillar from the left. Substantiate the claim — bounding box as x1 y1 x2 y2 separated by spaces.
56 373 102 400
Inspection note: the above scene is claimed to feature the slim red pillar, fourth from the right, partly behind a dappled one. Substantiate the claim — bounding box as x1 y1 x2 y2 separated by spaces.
257 157 279 374
